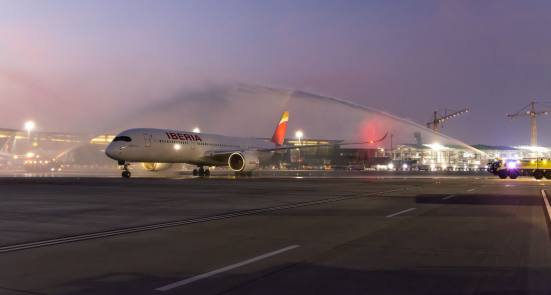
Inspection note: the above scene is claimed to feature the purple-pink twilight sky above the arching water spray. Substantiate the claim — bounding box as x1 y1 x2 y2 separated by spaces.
0 0 551 145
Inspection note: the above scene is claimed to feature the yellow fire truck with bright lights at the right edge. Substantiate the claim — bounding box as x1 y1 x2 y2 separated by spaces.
488 158 551 179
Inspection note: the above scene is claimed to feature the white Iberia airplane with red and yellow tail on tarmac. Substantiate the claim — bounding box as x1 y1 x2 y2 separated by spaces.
105 112 388 178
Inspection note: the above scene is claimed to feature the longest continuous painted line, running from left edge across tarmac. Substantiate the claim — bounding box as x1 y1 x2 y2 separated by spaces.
0 189 398 254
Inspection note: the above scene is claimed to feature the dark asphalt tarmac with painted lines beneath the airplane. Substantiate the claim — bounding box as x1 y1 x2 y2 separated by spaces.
0 176 551 294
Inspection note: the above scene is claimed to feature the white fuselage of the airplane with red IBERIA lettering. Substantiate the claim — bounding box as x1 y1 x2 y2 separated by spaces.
105 128 275 166
